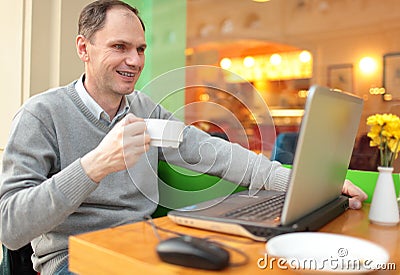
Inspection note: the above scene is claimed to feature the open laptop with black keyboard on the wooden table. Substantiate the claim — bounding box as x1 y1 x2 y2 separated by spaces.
168 85 363 241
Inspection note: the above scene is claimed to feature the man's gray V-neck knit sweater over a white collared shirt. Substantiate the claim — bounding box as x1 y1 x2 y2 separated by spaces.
0 82 289 275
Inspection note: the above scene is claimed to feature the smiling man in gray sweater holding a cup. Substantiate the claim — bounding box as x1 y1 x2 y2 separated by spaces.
0 0 365 274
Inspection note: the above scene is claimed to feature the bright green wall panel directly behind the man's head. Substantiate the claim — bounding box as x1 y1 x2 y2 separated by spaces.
125 0 186 119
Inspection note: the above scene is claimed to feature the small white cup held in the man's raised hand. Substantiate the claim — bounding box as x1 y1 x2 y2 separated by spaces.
144 118 185 148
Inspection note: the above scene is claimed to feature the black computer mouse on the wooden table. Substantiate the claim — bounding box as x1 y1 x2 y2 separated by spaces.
157 236 229 270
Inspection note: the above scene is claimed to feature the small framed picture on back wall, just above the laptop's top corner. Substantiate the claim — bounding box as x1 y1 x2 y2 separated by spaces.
328 63 354 93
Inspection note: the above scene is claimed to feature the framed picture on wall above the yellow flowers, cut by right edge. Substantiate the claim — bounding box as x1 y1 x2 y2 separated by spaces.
382 52 400 101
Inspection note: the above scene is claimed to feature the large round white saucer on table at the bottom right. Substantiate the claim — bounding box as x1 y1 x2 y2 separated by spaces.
266 232 389 274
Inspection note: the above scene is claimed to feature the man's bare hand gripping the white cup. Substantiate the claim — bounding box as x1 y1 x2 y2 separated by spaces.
81 114 150 182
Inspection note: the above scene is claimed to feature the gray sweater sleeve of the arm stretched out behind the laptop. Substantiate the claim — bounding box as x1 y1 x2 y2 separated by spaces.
162 126 291 191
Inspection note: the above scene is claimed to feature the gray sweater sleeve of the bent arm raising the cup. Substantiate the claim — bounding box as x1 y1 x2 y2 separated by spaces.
0 109 97 249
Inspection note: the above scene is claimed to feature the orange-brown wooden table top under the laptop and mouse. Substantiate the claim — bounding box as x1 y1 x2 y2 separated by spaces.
69 205 400 275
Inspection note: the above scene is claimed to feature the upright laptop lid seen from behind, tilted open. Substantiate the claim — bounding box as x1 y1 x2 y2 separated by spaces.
281 86 363 224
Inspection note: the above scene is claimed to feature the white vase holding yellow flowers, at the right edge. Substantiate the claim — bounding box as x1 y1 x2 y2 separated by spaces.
369 166 399 226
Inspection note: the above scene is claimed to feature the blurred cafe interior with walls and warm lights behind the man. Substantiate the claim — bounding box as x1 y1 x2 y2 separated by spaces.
0 0 400 172
